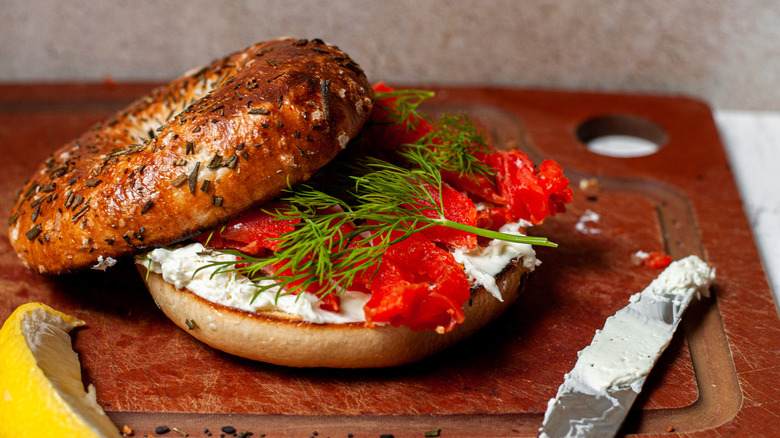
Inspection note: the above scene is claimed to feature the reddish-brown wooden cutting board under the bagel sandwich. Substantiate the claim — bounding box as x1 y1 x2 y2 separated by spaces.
0 84 780 437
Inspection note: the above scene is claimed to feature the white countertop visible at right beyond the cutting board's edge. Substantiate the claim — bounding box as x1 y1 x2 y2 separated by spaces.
714 110 780 309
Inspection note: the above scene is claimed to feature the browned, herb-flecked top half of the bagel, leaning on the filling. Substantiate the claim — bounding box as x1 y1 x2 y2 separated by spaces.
9 38 373 274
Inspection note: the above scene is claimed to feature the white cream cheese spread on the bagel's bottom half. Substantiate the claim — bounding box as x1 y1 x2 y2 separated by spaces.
138 224 541 324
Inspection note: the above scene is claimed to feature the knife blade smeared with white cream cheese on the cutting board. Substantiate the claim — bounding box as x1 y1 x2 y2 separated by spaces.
539 256 715 438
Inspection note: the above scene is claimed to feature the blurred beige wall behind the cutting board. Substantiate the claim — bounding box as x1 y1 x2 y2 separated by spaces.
0 0 780 110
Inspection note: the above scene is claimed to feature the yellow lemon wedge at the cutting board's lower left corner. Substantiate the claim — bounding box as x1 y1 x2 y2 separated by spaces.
0 303 120 437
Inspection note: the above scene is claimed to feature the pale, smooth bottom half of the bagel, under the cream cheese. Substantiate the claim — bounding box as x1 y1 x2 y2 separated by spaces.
136 262 529 368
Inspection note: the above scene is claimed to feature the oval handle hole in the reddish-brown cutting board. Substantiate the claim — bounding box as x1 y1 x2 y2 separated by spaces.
576 114 668 158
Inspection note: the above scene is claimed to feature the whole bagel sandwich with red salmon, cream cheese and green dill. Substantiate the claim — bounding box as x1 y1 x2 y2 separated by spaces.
9 38 572 368
